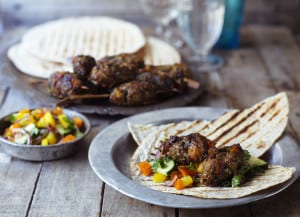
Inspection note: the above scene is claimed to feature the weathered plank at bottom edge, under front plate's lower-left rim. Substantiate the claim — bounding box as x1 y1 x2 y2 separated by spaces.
101 185 175 217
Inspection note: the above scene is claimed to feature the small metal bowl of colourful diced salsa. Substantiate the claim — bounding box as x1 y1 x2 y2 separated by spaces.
0 107 90 161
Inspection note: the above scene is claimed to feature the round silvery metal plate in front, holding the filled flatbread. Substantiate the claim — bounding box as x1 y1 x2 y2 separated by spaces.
89 107 300 208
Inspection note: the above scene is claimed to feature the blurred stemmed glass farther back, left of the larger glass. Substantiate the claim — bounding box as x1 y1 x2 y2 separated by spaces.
140 0 183 47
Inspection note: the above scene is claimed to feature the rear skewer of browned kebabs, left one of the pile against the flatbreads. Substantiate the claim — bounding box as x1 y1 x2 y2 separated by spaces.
48 54 143 99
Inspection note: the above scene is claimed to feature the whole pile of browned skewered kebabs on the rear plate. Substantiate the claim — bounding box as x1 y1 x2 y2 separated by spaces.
49 54 199 106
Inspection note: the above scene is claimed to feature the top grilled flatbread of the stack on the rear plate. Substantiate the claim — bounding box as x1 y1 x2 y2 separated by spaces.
22 17 146 63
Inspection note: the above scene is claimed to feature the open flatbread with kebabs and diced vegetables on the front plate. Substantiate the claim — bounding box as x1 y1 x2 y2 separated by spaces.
129 93 295 199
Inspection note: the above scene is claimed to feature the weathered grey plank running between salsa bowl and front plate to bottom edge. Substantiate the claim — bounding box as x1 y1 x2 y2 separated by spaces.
28 128 103 217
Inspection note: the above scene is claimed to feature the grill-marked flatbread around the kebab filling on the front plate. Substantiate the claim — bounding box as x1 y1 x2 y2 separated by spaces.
128 93 295 199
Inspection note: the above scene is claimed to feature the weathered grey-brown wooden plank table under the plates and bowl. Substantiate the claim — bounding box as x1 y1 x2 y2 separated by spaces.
0 23 300 217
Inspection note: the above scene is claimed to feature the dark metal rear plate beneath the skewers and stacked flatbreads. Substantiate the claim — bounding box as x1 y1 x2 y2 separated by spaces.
0 41 203 115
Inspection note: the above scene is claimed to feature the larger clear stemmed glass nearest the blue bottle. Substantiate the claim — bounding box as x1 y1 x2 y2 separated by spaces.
177 0 225 71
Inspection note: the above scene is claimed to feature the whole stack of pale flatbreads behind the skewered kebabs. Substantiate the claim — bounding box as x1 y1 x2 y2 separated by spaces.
8 17 181 78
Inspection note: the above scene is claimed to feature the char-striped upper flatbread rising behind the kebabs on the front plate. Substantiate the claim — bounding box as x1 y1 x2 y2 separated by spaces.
129 93 289 157
